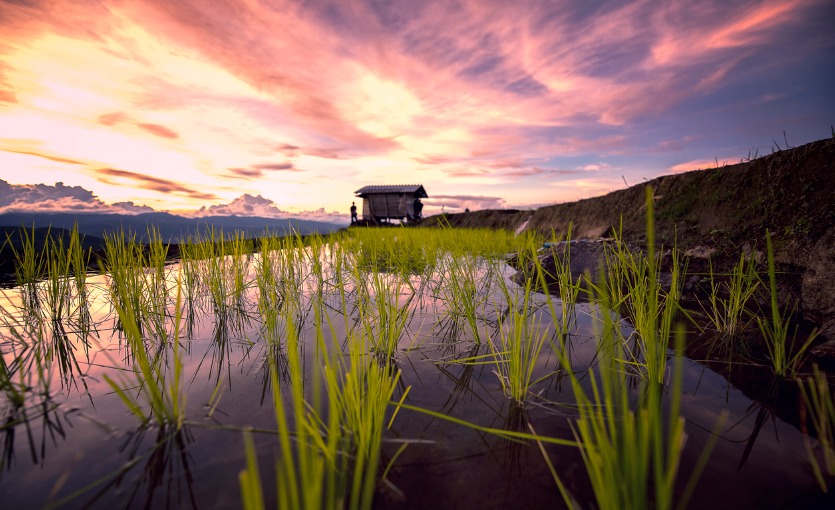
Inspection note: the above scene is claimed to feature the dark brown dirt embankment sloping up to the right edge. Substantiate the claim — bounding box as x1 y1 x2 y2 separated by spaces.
421 138 835 340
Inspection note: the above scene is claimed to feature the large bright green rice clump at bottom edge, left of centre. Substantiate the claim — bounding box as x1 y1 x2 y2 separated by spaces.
240 292 405 509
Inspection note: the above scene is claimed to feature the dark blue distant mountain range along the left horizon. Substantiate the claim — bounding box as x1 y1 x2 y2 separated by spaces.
0 212 340 243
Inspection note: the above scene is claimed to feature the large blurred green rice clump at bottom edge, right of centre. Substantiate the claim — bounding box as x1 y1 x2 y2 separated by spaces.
540 290 724 509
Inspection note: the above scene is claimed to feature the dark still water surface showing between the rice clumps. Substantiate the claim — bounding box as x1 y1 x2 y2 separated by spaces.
0 255 833 510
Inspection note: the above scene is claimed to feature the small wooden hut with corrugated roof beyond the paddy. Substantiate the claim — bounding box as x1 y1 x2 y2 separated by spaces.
354 184 429 223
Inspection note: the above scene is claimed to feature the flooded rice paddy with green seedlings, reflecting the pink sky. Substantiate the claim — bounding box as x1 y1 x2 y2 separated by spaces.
0 229 833 509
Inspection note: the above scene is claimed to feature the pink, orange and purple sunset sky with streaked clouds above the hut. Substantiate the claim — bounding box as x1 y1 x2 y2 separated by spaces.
0 0 835 220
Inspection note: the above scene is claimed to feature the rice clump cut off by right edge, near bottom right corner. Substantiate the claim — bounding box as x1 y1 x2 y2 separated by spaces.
796 365 835 492
